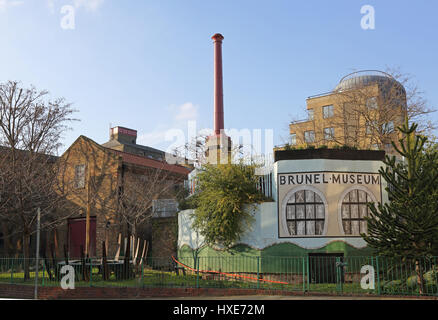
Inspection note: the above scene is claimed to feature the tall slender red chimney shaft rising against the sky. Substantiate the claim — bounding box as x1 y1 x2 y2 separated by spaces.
211 33 224 136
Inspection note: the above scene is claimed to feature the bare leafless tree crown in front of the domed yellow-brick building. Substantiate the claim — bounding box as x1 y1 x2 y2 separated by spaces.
293 68 437 151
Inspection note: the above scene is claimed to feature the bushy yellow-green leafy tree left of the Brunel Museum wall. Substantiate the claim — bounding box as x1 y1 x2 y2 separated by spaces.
192 163 264 248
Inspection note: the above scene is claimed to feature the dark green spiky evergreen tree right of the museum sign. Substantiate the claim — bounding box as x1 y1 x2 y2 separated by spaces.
362 122 438 293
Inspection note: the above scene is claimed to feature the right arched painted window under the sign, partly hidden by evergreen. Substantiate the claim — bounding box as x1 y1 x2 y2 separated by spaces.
341 189 375 236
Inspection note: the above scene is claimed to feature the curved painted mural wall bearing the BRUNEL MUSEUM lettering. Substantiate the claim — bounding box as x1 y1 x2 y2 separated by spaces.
178 159 387 256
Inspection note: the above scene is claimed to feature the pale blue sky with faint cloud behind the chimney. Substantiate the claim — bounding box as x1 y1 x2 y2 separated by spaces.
0 0 438 155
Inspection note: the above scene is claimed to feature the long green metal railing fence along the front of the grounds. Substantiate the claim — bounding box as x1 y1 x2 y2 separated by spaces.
0 255 438 296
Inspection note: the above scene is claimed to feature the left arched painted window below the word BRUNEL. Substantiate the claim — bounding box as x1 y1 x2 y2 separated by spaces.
286 189 325 236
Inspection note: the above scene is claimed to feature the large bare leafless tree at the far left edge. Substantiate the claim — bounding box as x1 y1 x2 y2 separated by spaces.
0 81 75 278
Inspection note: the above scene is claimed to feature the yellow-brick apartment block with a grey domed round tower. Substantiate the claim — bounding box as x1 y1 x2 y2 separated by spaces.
289 71 407 154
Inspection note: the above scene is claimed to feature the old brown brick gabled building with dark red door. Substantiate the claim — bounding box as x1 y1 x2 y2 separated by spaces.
56 127 190 257
